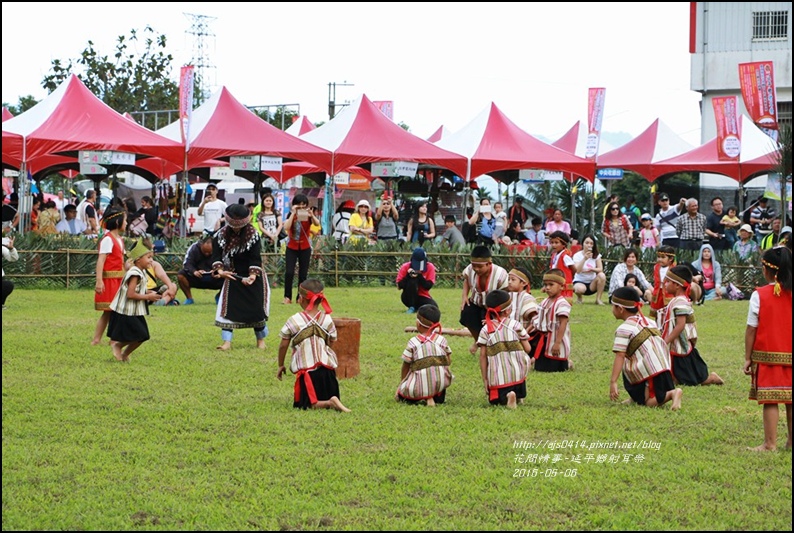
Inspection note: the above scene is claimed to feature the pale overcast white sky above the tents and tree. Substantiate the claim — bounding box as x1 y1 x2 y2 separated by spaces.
2 2 701 146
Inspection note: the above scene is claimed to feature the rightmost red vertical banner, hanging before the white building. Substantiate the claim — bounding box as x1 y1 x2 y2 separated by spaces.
739 61 778 141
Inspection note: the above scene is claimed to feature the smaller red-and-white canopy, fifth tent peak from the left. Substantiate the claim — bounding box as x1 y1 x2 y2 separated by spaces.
598 118 693 181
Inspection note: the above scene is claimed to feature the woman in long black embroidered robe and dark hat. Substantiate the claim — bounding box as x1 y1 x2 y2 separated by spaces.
212 203 270 350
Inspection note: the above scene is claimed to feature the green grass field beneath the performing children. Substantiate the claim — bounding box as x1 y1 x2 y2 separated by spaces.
2 287 792 530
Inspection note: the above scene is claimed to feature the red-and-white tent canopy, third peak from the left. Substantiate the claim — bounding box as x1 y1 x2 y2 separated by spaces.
301 95 466 175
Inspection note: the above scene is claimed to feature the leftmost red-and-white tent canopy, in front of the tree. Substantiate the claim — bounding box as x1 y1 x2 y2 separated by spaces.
3 74 184 163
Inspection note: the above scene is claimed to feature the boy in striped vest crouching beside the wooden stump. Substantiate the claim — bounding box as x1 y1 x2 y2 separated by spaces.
276 278 350 413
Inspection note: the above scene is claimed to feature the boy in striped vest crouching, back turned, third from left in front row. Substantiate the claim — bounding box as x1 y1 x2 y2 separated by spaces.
477 290 532 409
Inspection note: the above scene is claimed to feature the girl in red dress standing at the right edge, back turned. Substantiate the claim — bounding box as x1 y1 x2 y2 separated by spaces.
744 246 792 452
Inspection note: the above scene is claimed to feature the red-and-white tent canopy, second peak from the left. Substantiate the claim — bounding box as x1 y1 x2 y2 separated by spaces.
157 87 331 169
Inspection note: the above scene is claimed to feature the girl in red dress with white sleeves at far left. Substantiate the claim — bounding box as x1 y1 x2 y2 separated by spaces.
91 208 127 346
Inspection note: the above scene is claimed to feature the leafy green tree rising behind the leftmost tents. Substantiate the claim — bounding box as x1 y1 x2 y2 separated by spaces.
42 26 181 124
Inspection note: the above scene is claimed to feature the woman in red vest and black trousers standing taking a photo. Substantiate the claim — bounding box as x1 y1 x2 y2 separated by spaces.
283 194 320 304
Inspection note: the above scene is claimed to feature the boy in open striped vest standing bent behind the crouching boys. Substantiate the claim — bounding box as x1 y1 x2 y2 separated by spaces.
460 245 508 354
